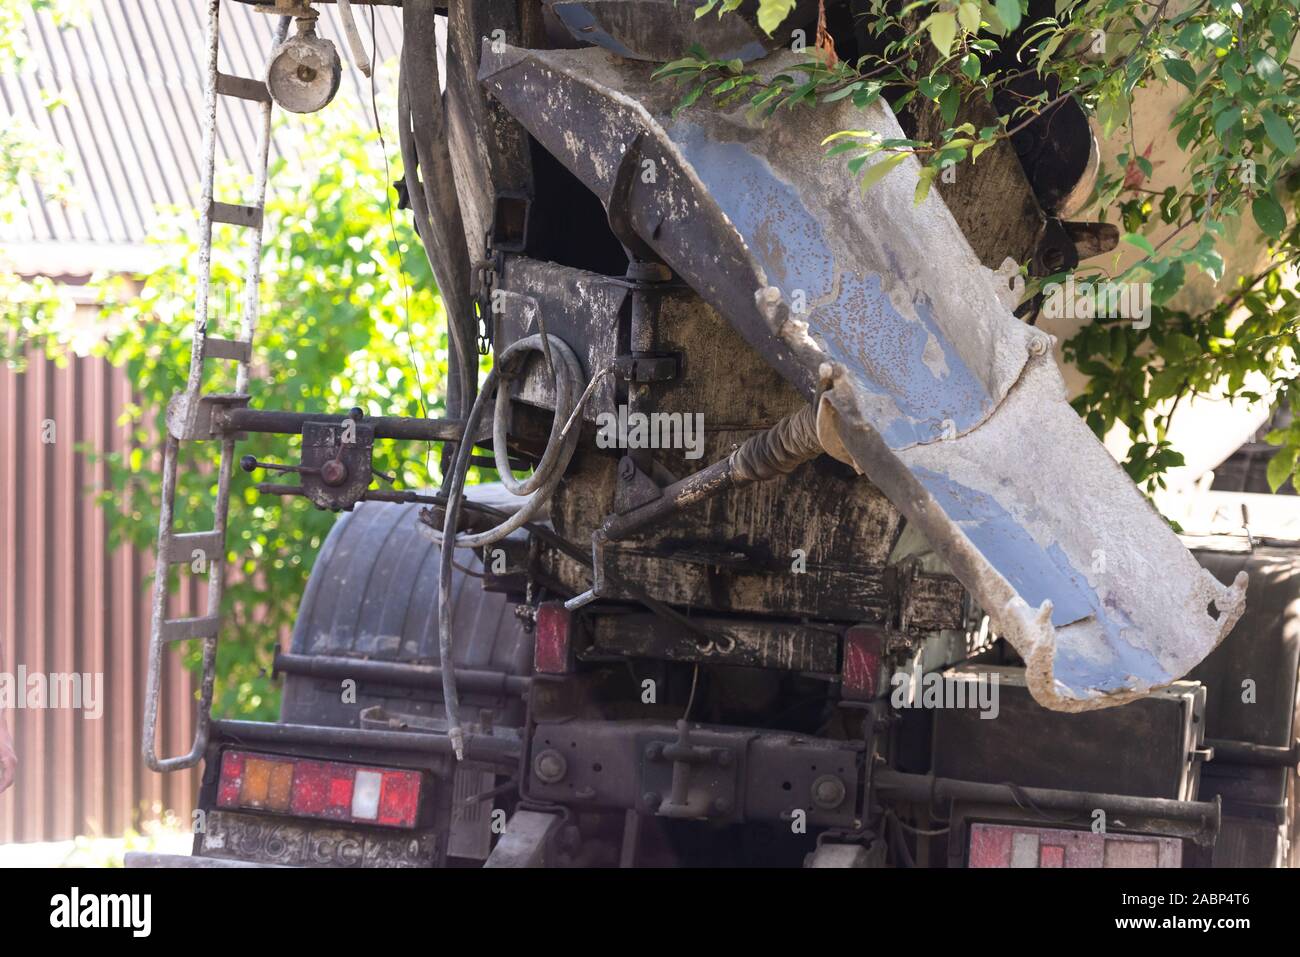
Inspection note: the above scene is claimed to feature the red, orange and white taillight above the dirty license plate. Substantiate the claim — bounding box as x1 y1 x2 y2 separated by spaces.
217 750 424 827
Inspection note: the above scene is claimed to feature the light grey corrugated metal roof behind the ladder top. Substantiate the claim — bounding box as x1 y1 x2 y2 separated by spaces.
0 0 402 260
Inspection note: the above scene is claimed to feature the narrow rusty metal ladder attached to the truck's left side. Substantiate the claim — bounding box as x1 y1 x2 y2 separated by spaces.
142 0 289 771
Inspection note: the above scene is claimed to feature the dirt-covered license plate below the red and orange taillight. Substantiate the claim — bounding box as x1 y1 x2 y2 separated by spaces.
199 811 438 867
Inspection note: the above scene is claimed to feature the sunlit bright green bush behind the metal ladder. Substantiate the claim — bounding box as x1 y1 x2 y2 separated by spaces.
85 109 447 718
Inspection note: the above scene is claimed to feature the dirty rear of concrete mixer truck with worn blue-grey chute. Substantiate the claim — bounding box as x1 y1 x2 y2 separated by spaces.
126 0 1300 867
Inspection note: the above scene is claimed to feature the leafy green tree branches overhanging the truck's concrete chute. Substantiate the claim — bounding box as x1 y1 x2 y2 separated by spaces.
658 0 1300 489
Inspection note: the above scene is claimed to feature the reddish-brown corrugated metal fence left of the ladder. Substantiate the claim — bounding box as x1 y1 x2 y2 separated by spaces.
0 356 200 843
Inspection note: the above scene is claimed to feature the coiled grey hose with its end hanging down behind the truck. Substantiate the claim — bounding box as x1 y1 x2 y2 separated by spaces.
438 333 588 761
